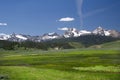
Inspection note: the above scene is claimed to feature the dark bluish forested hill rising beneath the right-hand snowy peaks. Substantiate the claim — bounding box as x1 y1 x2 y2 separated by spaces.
44 35 119 48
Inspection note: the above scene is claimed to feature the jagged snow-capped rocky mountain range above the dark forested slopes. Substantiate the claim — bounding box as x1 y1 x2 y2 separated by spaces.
0 27 120 42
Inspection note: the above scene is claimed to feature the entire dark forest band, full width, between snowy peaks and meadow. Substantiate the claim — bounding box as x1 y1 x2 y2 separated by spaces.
0 35 119 50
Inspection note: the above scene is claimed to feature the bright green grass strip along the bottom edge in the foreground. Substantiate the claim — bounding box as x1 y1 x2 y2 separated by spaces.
0 66 119 80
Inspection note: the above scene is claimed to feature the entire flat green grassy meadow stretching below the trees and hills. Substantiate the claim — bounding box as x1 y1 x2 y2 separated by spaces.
0 49 120 80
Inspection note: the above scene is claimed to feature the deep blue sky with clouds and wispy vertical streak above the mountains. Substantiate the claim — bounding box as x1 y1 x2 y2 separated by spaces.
0 0 120 35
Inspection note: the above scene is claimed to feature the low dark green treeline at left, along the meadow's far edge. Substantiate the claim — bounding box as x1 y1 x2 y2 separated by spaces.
0 40 73 50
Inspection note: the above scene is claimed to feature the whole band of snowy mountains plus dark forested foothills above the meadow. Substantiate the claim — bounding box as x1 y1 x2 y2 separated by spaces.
0 27 120 50
